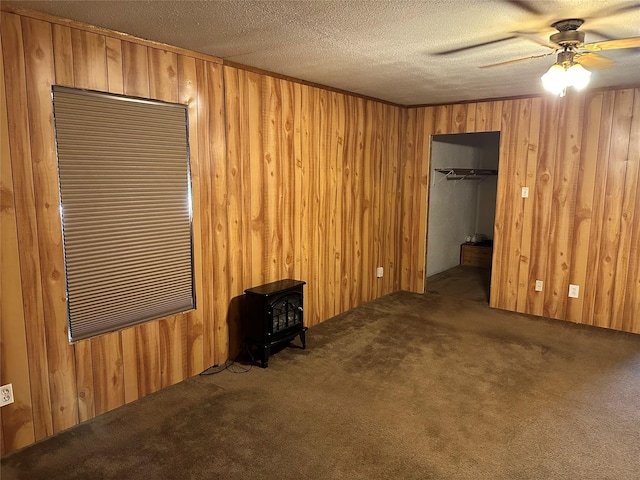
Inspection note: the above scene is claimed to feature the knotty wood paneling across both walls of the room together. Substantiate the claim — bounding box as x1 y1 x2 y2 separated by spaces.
0 4 640 453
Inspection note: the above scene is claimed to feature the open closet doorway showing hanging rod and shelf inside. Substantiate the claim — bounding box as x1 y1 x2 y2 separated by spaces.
425 132 500 302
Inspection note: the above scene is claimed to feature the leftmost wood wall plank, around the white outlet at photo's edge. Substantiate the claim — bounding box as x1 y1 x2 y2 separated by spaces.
0 34 35 455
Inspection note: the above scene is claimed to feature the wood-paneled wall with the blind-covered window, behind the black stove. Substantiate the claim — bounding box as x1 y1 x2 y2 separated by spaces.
0 11 402 453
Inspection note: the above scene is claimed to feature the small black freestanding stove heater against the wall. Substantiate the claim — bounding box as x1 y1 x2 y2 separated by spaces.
243 279 307 368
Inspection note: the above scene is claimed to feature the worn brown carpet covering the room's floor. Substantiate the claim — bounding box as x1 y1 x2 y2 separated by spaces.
1 272 640 480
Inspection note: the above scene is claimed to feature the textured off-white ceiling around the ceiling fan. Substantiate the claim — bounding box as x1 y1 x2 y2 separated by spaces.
7 0 640 105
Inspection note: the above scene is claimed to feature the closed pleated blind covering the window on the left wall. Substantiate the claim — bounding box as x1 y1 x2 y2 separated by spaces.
52 85 195 341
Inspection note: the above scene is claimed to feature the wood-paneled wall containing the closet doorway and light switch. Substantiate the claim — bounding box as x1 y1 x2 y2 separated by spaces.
401 93 640 333
